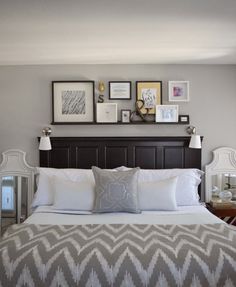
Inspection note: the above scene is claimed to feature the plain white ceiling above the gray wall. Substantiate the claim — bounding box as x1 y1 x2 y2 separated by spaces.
0 0 236 65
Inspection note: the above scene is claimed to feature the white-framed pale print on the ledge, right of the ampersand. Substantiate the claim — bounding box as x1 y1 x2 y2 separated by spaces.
156 105 179 123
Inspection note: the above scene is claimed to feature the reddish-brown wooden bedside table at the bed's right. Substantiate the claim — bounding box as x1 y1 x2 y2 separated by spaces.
206 203 236 226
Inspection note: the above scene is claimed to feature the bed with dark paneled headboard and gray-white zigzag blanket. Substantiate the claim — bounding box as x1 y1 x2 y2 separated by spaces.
0 137 236 287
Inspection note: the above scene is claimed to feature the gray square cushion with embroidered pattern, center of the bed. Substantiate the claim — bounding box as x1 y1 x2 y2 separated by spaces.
92 166 140 213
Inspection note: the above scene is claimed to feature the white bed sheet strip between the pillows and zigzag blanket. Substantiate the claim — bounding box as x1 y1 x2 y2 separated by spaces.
25 206 224 225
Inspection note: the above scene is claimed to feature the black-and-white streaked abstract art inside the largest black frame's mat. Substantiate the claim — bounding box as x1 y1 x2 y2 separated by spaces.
61 90 86 115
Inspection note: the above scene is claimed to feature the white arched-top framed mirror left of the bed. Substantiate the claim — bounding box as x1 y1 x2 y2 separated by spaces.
0 149 35 237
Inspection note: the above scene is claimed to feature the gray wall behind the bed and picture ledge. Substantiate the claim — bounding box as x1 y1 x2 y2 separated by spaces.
0 65 236 168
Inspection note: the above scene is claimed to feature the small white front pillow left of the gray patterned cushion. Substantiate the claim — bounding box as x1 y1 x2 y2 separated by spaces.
52 176 95 211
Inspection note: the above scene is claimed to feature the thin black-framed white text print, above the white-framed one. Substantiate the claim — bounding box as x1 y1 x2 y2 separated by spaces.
109 81 131 100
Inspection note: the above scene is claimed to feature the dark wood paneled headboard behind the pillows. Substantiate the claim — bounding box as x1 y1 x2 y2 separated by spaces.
40 137 201 169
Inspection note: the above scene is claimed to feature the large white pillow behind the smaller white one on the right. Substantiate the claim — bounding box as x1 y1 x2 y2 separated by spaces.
116 166 204 206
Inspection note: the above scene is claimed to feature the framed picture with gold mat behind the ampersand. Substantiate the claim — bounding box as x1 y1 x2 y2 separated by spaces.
136 81 162 114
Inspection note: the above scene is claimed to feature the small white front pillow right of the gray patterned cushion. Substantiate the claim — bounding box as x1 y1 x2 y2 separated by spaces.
138 177 178 210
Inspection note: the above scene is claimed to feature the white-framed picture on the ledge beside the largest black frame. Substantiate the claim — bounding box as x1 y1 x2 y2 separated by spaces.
97 103 117 123
